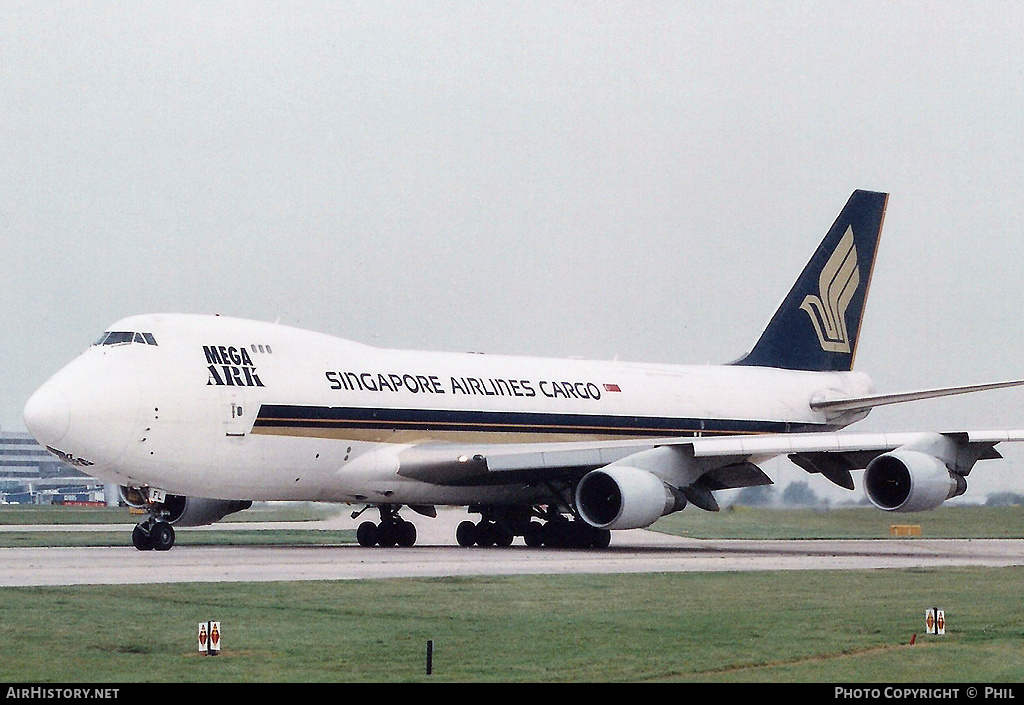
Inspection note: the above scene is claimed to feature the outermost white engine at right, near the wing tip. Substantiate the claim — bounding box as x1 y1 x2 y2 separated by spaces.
864 448 967 511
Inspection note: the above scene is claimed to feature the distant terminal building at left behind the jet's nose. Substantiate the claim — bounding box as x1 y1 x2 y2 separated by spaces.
0 430 109 504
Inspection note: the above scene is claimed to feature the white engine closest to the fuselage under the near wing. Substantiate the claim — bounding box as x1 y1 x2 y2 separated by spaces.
575 465 685 529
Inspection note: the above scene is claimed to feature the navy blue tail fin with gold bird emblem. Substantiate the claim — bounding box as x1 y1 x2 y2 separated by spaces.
733 191 889 371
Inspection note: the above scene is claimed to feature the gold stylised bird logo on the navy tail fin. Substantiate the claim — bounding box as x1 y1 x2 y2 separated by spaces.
800 226 860 353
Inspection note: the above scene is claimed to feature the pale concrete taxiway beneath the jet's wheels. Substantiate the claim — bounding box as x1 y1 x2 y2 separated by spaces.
0 510 1024 586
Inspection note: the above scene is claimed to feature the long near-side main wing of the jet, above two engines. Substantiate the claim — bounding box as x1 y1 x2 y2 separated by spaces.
398 429 1024 501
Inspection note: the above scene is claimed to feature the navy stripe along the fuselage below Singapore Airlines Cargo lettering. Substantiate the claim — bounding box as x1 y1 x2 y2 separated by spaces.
254 405 823 436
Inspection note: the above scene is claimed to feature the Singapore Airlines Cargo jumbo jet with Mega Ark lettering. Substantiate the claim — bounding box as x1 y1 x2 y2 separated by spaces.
25 191 1024 550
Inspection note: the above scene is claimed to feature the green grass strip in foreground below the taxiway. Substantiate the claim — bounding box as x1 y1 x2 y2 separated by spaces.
0 568 1024 683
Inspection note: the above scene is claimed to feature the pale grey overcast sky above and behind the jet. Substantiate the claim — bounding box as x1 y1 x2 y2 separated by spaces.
0 0 1024 491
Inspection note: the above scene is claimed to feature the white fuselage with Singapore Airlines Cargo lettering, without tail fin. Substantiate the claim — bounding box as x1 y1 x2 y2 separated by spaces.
26 315 870 504
